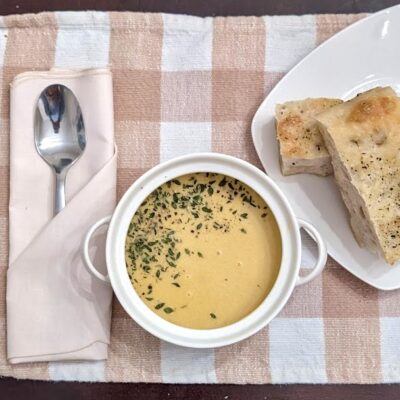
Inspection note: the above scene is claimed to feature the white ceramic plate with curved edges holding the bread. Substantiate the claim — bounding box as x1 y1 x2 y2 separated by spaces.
252 6 400 290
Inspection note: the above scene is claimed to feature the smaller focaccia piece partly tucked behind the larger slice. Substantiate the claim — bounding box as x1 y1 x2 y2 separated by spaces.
275 98 342 176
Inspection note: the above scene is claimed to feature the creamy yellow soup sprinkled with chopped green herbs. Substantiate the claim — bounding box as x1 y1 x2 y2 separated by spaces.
125 173 282 329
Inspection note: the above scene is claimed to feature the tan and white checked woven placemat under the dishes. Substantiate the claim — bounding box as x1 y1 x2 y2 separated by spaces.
0 12 400 383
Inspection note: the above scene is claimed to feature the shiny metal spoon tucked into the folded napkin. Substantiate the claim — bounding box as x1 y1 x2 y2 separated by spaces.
34 84 86 214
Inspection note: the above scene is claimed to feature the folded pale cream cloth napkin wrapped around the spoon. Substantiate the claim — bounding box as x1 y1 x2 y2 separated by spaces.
7 69 117 363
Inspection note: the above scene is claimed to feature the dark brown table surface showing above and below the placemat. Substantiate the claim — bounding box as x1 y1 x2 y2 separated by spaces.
0 0 400 400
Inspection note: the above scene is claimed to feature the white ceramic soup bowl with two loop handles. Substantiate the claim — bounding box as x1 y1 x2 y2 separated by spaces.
83 153 327 348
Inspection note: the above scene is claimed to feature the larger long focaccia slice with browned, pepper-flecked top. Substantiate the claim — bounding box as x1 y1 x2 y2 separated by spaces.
317 87 400 264
